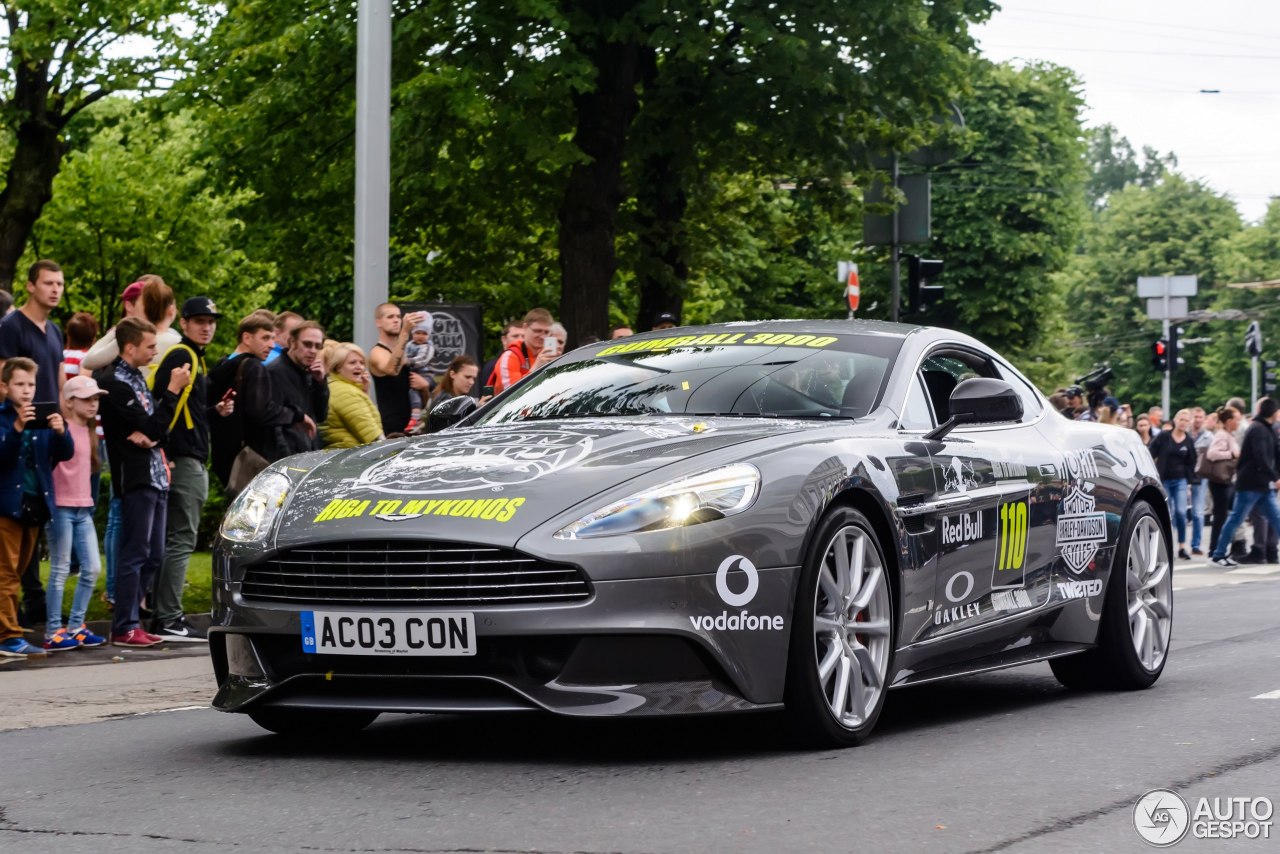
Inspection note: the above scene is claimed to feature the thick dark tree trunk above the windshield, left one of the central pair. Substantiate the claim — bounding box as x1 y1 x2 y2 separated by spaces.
559 0 648 344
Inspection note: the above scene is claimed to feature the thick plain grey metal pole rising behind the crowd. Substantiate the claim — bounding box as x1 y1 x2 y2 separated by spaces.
352 0 392 371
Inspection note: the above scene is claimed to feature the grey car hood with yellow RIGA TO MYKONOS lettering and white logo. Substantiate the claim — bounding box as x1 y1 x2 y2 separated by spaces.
275 416 814 548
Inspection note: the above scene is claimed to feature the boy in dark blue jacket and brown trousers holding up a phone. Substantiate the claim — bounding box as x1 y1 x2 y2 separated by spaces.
0 356 76 658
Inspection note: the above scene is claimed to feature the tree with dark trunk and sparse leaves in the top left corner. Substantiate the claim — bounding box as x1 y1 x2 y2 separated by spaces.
0 0 198 289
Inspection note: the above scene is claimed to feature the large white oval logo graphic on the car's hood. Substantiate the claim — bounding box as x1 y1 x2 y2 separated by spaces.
351 430 593 495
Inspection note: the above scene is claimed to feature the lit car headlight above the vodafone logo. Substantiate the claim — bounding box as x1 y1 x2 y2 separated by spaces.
556 462 760 540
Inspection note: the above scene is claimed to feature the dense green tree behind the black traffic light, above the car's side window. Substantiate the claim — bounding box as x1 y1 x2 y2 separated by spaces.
904 61 1087 379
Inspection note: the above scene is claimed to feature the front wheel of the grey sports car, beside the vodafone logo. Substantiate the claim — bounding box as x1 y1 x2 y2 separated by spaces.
786 507 897 749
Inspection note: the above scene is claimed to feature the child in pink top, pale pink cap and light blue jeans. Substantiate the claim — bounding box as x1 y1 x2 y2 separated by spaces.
45 376 106 652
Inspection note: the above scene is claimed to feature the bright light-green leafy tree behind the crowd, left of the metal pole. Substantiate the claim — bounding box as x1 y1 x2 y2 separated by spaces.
27 99 275 350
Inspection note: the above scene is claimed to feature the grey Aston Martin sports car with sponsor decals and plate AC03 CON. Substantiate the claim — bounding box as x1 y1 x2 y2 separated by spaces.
210 320 1172 745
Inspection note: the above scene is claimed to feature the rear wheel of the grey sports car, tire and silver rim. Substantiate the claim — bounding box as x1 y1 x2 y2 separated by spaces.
1050 501 1174 691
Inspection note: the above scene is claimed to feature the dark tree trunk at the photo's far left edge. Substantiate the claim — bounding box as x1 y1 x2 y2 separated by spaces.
0 61 67 291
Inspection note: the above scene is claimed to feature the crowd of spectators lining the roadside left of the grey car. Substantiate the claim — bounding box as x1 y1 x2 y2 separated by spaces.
0 260 676 658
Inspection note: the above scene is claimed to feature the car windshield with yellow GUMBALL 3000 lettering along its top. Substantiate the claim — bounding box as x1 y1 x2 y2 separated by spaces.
474 332 902 424
